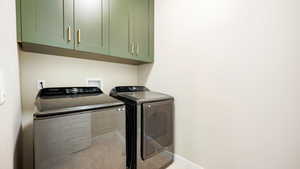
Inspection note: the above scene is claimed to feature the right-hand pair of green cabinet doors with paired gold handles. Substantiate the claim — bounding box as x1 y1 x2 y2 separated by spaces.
110 0 154 62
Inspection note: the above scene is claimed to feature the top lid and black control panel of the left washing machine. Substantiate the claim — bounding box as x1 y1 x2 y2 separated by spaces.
34 87 124 117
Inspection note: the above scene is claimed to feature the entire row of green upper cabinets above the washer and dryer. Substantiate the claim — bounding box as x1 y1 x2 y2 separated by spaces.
16 0 154 64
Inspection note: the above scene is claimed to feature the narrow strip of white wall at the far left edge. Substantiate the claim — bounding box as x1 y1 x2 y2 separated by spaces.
0 0 21 169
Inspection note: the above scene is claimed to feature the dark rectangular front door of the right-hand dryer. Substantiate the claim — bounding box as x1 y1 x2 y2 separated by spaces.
142 100 174 160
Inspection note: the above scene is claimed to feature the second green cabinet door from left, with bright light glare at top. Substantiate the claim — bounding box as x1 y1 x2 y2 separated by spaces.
74 0 109 54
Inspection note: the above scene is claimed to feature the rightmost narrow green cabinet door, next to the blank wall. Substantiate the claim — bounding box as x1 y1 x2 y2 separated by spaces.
133 0 154 62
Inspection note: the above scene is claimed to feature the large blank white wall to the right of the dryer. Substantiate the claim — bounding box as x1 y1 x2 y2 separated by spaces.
139 0 300 169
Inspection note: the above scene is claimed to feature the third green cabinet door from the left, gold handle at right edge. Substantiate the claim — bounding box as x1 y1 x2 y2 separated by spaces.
110 0 133 58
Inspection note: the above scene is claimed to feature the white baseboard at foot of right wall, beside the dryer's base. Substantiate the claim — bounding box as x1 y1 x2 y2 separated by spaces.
173 154 204 169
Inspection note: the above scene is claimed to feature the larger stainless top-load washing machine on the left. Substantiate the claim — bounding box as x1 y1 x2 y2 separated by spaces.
34 87 126 169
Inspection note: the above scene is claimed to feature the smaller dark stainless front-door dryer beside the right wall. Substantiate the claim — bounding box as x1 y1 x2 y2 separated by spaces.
110 86 174 169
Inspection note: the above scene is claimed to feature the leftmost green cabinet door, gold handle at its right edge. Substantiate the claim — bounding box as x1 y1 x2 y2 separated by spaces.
21 0 74 49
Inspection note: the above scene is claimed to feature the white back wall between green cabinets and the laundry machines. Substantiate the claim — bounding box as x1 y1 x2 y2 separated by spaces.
19 51 138 169
